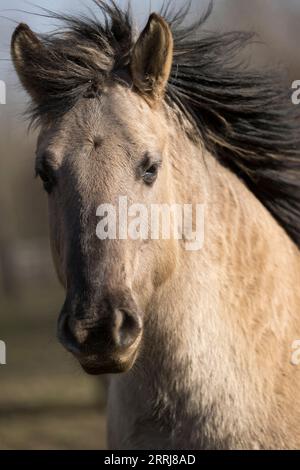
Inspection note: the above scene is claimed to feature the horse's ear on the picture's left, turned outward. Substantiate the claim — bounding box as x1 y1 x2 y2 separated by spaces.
11 23 45 102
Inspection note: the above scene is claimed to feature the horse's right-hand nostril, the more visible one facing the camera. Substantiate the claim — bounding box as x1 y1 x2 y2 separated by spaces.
113 309 142 348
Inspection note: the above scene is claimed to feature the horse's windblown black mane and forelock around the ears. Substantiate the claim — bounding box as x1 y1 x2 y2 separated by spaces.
22 0 300 246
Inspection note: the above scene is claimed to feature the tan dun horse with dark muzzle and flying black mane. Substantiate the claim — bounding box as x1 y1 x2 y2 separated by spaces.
11 0 300 450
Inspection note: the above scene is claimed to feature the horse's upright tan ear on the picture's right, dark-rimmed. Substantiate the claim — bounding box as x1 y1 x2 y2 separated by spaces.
131 13 173 102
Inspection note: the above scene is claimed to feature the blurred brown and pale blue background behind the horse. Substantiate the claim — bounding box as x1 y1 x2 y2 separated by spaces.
0 0 300 449
